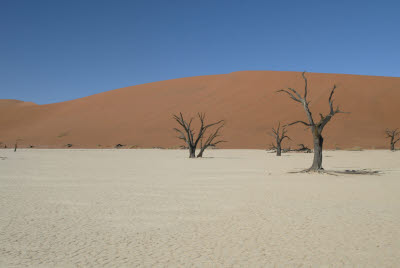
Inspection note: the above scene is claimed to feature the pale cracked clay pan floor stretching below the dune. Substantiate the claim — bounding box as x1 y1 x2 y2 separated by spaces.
0 150 400 267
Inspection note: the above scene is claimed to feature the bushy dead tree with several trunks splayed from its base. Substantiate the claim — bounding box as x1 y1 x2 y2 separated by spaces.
173 113 225 158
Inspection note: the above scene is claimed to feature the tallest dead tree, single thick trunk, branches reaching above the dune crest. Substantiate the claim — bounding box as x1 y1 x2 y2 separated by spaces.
278 72 344 171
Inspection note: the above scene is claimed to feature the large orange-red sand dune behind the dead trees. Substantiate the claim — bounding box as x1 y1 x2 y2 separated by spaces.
0 71 400 149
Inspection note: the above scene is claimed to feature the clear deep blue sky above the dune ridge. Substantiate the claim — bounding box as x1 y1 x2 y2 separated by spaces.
0 0 400 104
